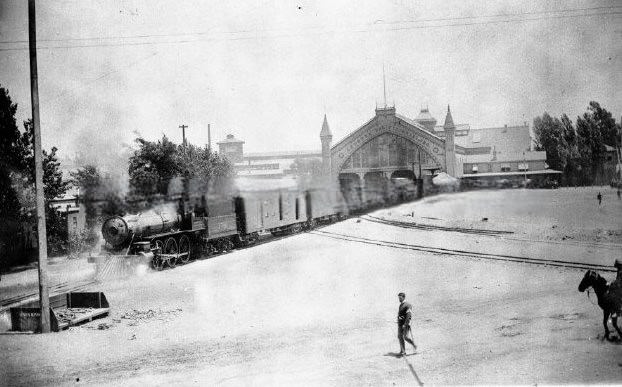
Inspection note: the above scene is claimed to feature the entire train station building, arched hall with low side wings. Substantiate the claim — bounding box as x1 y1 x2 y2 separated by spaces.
218 106 561 194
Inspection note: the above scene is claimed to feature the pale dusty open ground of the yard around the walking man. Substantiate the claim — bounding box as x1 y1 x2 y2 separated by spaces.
0 188 622 386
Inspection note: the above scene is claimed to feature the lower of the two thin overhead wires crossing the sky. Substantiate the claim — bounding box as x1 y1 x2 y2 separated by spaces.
0 7 622 52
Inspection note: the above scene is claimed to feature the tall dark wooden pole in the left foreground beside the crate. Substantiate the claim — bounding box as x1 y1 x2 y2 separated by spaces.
28 0 50 333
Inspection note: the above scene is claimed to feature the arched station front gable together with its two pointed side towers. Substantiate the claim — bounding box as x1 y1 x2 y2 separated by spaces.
320 107 456 202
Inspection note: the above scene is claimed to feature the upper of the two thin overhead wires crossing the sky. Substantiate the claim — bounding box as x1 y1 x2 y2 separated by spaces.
0 5 622 44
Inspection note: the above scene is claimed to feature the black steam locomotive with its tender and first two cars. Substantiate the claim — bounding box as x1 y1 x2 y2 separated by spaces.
102 186 348 270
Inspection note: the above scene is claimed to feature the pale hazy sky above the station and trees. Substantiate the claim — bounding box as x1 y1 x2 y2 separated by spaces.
0 0 622 168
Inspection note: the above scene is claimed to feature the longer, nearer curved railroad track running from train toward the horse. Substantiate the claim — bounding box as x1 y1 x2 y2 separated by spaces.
310 230 617 272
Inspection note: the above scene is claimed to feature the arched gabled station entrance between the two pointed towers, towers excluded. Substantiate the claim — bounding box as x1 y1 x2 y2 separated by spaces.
331 108 445 208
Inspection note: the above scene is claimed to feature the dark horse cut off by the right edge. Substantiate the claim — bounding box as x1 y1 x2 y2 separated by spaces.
579 270 622 341
